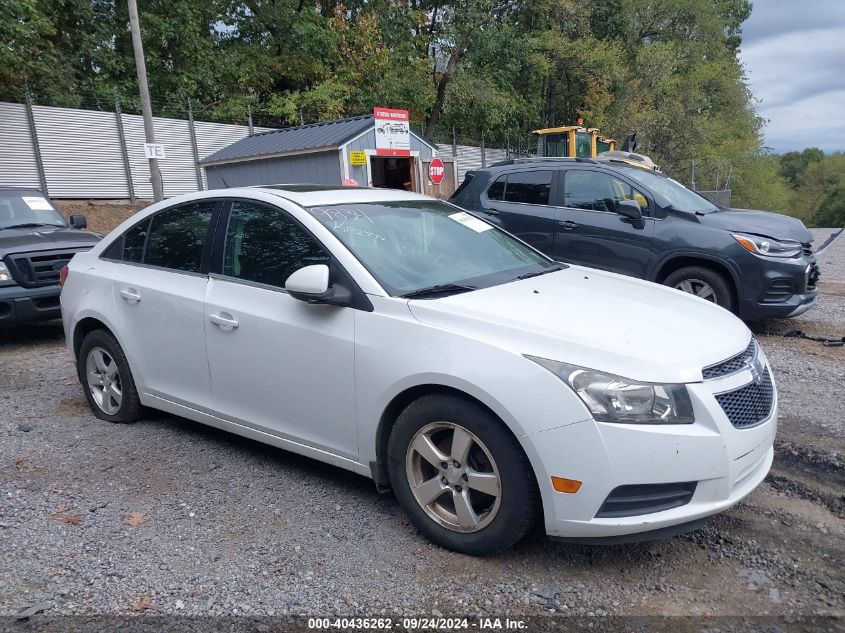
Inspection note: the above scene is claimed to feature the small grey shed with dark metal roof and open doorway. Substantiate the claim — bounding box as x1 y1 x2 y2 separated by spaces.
202 114 436 191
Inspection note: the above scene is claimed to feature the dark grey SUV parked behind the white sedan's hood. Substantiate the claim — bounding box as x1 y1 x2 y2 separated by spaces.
451 158 819 320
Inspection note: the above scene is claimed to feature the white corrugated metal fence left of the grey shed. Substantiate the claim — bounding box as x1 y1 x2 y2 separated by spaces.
0 102 268 199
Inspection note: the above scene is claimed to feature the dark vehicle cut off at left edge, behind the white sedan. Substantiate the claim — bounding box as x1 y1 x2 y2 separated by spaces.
0 187 100 328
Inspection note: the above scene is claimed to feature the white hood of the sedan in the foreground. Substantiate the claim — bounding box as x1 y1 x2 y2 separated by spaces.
408 266 751 383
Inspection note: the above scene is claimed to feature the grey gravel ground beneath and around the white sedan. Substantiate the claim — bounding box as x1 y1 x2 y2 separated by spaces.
0 225 845 616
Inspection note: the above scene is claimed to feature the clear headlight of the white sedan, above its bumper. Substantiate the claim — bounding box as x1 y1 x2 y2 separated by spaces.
526 356 695 424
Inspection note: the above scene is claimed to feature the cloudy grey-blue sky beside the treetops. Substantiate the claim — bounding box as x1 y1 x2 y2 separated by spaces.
740 0 845 152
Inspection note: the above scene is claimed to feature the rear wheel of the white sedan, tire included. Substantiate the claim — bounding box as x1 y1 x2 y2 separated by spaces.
76 330 141 422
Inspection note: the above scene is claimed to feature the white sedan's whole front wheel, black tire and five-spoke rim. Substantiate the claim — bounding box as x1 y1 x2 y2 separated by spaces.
388 395 538 555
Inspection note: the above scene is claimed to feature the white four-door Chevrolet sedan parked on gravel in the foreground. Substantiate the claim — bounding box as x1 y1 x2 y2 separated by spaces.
61 185 777 554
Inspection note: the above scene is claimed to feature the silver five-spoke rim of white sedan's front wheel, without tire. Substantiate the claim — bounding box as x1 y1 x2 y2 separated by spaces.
405 422 502 533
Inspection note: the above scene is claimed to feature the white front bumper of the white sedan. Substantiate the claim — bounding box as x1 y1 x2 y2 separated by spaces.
520 354 777 539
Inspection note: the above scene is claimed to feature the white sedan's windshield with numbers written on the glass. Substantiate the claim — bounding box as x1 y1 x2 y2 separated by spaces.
308 200 561 296
